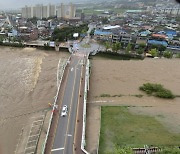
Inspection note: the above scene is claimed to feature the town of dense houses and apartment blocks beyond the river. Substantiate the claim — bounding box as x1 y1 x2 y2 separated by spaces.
0 1 180 56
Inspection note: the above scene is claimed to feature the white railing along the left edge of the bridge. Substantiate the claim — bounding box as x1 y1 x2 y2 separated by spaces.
42 56 71 154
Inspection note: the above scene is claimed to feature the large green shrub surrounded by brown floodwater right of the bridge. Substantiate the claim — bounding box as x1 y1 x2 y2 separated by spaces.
139 83 175 99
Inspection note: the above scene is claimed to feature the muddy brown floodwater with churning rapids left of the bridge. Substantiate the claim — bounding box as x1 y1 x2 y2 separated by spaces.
0 47 69 154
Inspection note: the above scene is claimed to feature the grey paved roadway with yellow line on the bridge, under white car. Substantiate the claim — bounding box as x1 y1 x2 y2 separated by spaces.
51 53 84 154
